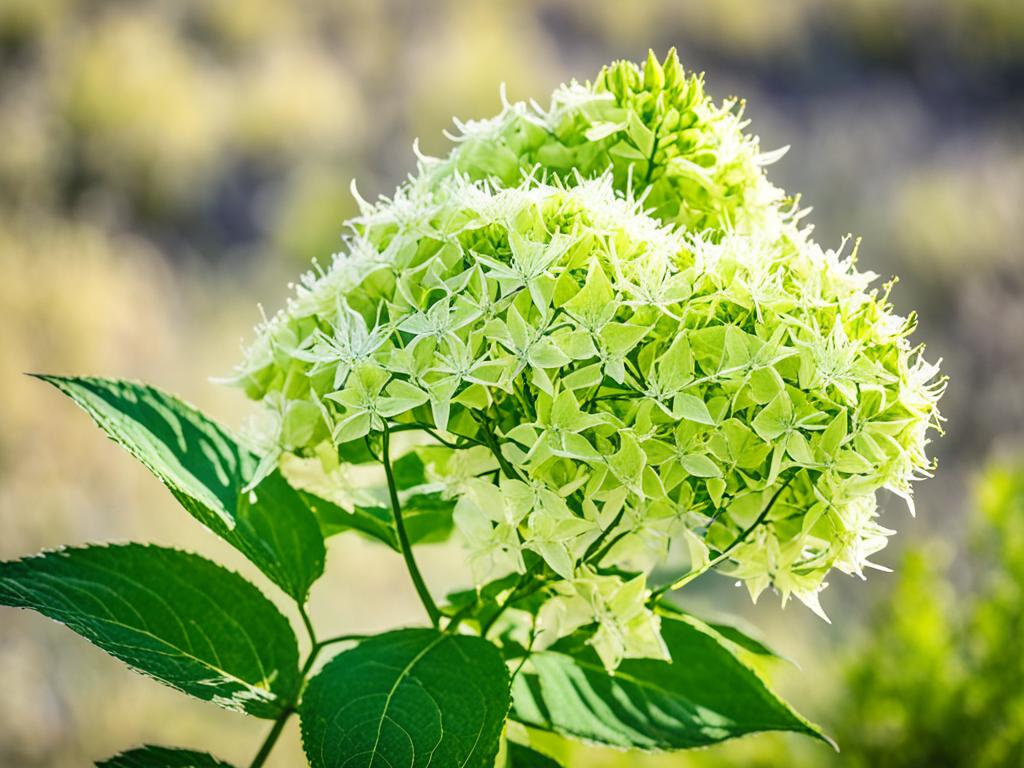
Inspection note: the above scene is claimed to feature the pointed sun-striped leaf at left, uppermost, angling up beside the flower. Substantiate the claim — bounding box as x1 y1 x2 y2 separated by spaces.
39 376 325 603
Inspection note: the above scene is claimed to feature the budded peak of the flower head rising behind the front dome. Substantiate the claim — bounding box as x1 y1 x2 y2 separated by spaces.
433 50 782 230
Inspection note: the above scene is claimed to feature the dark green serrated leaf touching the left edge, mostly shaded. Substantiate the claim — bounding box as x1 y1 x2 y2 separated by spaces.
0 544 299 718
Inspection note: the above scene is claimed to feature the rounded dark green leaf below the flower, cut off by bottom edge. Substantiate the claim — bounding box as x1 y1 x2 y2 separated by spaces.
299 629 509 768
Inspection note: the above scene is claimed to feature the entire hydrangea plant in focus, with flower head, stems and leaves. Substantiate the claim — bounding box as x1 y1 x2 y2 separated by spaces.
0 52 943 766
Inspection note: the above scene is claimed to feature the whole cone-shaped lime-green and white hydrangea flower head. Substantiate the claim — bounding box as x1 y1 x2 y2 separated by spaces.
232 53 942 668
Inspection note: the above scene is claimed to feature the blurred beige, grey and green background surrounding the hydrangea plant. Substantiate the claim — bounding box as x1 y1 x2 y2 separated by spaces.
0 0 1024 768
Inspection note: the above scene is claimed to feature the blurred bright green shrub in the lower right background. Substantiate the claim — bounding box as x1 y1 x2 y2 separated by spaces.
836 460 1024 768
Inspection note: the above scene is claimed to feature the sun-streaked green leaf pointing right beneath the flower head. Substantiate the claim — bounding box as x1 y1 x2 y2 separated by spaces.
512 616 827 750
